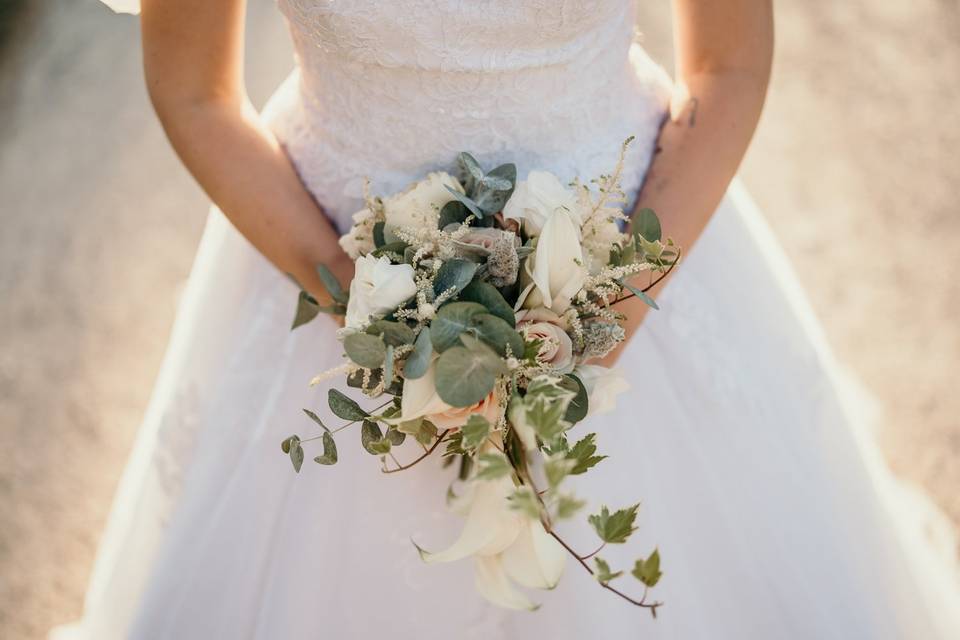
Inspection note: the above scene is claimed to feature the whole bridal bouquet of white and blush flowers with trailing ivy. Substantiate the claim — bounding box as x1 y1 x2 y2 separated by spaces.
282 140 680 615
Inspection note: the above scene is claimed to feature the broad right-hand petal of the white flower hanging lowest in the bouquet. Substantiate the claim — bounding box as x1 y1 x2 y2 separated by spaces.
500 520 567 589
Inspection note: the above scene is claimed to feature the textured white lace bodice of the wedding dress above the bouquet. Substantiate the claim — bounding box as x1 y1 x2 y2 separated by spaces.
266 0 669 230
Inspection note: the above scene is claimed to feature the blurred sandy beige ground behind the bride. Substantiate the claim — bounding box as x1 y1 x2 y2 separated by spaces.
0 0 960 640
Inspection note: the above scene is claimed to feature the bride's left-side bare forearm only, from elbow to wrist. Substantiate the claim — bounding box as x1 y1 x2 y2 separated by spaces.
157 96 353 304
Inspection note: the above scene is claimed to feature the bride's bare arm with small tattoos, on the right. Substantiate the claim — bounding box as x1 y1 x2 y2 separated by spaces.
604 0 773 365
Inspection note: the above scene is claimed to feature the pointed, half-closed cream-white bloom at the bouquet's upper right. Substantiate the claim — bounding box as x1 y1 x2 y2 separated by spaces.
521 209 587 313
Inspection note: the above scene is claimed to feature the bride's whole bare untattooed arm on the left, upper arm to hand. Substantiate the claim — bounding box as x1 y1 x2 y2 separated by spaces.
141 0 353 305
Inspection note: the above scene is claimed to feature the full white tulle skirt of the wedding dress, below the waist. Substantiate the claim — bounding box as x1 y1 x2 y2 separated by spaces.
53 178 960 640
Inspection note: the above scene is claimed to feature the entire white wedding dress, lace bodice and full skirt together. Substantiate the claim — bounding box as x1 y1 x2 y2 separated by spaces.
53 0 960 640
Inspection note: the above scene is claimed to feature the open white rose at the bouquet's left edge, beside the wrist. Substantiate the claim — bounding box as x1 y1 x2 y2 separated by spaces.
345 256 417 329
